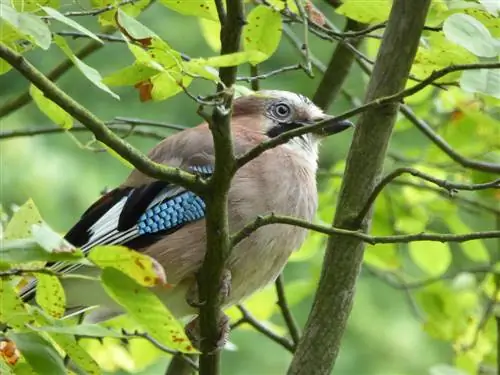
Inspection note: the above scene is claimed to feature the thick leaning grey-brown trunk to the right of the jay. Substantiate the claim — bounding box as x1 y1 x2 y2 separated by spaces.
288 0 434 375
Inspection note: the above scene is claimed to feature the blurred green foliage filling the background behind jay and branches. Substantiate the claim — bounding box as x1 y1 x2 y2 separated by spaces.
0 0 500 375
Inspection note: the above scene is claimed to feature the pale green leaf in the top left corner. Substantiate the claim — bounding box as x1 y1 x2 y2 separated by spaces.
0 1 52 50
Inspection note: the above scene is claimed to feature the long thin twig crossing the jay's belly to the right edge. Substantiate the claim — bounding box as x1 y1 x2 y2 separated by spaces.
231 214 500 247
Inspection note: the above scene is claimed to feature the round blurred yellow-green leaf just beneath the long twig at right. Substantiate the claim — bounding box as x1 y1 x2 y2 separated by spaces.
409 241 451 276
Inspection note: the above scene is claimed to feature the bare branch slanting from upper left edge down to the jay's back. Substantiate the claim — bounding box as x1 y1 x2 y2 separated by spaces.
0 44 206 193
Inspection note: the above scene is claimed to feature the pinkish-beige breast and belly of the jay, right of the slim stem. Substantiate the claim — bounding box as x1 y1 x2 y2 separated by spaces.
228 153 317 302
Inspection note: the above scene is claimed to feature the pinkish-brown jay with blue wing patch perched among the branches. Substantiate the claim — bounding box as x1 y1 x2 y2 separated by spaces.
16 90 353 350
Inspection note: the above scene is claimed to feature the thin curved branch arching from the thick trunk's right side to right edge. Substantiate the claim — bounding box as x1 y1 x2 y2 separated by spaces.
356 167 500 222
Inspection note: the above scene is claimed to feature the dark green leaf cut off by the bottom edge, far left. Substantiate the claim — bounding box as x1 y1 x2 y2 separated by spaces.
7 332 66 375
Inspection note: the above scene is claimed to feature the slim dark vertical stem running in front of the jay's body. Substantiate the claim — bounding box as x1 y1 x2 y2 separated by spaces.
197 0 245 375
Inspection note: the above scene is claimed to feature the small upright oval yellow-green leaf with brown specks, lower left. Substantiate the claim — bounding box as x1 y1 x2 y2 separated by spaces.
35 273 66 318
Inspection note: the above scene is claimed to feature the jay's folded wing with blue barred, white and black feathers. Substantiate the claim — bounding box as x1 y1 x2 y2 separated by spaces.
21 164 213 300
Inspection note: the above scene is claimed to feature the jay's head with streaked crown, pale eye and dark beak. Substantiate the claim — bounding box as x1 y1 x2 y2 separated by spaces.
233 90 353 154
